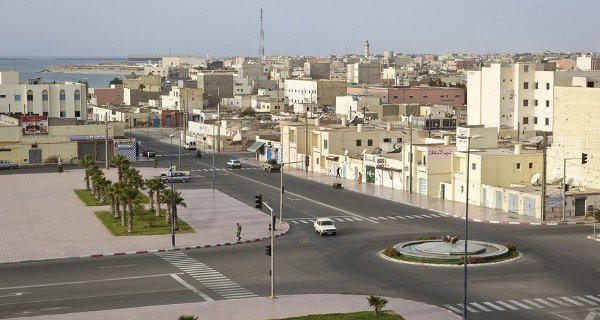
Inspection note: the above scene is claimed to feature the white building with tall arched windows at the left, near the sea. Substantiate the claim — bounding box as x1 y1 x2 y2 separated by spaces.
0 71 87 119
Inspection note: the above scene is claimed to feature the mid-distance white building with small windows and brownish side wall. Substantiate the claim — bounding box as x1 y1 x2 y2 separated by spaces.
284 79 346 107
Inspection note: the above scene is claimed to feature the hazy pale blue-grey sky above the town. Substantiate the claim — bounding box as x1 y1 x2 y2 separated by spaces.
0 0 600 56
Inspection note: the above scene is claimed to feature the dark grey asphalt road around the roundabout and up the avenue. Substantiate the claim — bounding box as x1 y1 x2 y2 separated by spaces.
0 128 600 320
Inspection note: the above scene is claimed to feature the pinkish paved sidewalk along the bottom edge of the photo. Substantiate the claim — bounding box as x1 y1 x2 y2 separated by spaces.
5 294 461 320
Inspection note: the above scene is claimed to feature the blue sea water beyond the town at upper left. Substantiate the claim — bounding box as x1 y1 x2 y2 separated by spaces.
0 58 124 88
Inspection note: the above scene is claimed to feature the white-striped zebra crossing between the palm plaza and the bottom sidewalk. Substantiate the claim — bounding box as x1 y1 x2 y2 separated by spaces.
156 251 258 299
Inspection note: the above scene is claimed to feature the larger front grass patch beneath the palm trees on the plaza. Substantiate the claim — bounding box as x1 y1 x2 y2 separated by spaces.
95 209 195 236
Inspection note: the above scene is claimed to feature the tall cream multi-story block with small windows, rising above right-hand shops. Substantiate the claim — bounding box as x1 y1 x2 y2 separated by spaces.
467 63 600 131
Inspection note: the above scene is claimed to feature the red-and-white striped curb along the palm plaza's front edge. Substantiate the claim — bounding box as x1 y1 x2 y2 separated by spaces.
0 228 290 264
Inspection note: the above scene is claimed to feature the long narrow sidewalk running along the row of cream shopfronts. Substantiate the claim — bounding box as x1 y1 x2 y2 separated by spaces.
242 157 593 226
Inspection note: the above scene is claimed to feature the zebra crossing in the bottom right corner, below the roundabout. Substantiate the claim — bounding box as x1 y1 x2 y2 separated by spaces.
443 295 600 315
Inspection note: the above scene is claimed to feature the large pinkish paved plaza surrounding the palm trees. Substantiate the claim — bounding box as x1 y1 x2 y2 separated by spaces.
0 168 289 263
